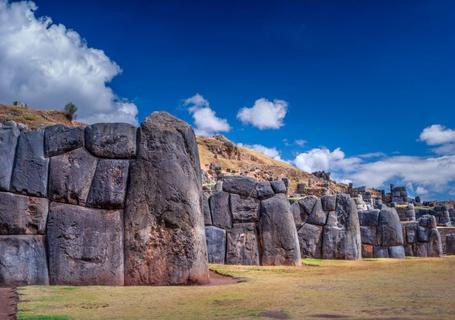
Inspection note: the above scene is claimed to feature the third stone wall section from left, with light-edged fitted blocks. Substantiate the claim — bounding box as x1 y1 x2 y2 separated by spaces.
291 194 361 259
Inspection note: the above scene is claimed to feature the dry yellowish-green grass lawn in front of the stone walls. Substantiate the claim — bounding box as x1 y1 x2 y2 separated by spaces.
18 256 455 320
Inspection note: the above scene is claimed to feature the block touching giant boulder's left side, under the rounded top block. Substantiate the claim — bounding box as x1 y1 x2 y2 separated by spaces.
87 159 129 209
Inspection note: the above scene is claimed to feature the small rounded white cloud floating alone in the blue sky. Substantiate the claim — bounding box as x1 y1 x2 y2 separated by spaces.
237 98 288 130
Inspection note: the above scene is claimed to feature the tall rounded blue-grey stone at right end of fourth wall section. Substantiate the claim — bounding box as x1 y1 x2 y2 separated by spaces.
378 206 403 247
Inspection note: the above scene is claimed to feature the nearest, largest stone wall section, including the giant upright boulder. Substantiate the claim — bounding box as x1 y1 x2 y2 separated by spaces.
0 113 208 285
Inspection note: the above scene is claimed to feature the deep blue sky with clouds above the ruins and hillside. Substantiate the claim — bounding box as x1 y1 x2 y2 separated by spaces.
0 0 455 198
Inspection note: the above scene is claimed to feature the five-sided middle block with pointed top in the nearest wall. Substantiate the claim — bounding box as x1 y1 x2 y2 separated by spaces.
49 148 97 205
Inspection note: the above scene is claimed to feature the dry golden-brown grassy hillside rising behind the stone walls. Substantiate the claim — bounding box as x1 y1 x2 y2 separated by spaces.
0 104 347 195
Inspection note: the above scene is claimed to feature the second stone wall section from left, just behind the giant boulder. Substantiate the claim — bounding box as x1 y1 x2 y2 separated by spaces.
204 176 300 265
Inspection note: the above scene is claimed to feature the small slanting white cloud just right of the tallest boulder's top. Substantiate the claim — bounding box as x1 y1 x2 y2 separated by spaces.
184 93 231 136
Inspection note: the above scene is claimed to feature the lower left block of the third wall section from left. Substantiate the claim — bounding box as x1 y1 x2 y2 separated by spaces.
297 223 322 258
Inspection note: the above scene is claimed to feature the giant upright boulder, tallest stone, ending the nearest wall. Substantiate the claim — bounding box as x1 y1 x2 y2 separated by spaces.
125 112 209 285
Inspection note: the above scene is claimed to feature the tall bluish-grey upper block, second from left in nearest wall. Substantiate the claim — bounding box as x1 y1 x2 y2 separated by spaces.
11 130 49 197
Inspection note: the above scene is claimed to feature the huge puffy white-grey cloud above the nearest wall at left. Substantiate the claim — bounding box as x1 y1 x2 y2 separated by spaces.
0 0 137 124
